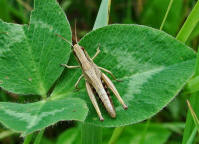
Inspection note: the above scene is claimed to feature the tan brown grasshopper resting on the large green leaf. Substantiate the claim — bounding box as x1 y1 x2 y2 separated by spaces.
58 35 128 121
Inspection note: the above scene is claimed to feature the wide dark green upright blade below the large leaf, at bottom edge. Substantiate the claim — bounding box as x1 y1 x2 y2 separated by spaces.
81 123 102 144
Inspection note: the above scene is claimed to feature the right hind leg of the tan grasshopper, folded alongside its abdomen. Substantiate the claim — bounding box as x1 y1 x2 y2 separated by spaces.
102 73 128 109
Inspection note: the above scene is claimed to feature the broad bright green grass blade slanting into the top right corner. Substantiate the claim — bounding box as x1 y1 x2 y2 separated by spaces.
176 1 199 42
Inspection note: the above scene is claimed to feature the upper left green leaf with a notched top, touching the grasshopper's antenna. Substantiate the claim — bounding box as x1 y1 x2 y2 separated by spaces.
0 0 71 96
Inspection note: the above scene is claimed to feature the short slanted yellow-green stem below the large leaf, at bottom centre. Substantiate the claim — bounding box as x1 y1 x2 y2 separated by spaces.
108 127 125 144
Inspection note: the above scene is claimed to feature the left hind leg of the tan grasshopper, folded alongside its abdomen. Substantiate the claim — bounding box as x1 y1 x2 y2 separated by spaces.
86 81 104 121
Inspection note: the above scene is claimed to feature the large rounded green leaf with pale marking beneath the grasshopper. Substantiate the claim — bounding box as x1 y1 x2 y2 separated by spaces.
51 25 196 127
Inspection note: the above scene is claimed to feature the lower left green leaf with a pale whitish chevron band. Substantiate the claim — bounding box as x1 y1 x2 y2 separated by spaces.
0 98 88 136
